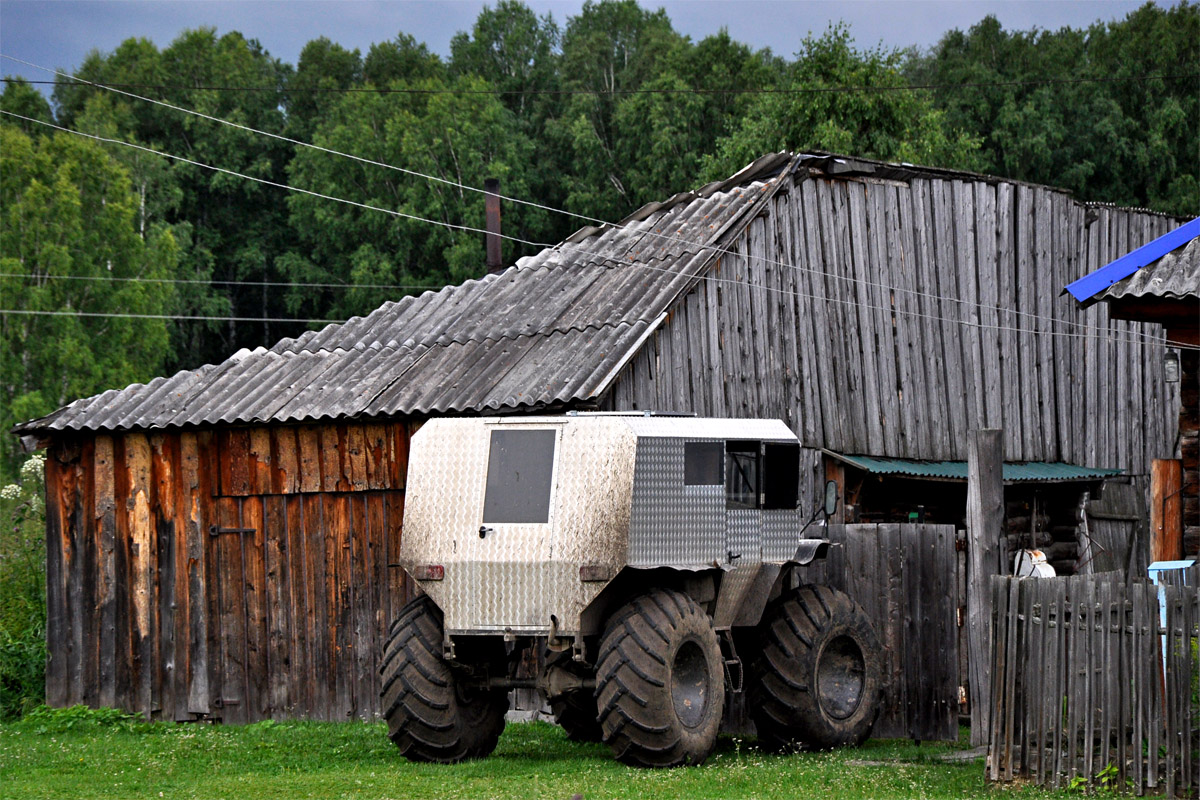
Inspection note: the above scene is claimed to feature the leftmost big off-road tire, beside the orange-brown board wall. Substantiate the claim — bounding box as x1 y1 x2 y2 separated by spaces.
379 595 509 764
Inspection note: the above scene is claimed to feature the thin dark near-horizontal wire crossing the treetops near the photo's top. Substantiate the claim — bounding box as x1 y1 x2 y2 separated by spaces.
2 72 1200 97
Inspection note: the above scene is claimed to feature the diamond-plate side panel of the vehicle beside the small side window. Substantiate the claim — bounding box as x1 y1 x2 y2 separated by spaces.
628 441 726 566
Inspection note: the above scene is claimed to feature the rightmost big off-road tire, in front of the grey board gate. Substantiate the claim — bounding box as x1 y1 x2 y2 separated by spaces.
748 585 882 750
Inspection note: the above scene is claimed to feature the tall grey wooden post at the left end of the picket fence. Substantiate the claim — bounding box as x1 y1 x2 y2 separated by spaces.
967 429 1004 747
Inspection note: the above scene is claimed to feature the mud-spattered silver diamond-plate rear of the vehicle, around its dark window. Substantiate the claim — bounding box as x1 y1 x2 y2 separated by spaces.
400 417 636 633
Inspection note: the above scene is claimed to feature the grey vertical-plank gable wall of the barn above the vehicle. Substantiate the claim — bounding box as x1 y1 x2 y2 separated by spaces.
604 176 1178 501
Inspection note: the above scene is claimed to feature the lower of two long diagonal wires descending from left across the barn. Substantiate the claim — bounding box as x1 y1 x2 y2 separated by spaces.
7 110 1200 350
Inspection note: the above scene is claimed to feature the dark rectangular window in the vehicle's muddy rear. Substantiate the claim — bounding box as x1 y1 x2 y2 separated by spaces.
484 431 554 523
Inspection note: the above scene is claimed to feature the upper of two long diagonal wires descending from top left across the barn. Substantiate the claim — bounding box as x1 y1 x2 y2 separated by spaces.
0 54 1180 347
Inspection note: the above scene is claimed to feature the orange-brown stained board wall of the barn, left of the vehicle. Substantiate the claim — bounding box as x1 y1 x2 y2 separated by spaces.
46 423 410 722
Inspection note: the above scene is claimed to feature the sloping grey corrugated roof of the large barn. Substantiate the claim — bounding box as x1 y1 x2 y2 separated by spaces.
13 154 794 433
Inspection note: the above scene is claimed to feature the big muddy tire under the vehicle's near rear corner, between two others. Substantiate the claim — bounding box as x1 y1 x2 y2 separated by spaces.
596 589 725 766
